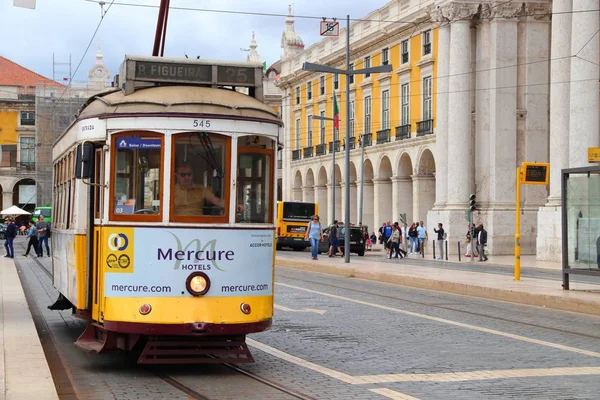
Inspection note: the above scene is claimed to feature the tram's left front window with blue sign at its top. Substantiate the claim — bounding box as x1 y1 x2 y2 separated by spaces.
113 135 162 215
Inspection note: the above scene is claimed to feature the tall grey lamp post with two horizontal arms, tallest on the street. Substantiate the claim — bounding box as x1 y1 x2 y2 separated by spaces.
302 15 393 263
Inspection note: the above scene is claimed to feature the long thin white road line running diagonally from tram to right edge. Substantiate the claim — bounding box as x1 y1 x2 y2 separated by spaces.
277 283 600 357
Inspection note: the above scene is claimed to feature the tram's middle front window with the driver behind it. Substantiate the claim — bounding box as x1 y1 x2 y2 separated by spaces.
171 132 229 217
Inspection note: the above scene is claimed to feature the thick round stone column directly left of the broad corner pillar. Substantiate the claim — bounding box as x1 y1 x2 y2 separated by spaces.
448 3 479 206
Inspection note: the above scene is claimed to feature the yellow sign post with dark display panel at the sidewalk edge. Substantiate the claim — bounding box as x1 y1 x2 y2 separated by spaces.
515 162 550 281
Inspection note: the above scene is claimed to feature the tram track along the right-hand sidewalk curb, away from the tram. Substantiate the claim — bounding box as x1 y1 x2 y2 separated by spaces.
275 270 600 340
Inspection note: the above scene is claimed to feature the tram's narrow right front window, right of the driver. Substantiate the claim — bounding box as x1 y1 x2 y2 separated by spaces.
235 136 275 223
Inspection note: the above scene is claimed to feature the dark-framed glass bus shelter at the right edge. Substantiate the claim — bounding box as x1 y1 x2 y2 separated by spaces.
562 167 600 290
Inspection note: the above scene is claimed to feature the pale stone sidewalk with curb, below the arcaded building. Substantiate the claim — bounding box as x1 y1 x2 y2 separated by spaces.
275 250 600 315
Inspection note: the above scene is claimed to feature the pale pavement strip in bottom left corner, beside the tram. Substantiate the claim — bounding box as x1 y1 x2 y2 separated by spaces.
0 255 58 400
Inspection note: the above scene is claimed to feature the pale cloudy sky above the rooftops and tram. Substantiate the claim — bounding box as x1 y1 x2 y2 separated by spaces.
0 0 388 81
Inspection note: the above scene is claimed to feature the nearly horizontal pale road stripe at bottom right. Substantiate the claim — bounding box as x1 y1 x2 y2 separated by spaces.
355 367 600 384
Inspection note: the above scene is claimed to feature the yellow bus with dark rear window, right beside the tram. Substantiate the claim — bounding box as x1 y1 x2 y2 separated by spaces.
277 201 319 251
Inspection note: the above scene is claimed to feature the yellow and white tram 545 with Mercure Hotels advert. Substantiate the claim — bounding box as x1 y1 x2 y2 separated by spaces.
51 57 282 363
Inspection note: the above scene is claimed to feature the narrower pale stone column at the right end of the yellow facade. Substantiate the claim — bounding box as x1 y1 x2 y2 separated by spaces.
432 7 450 209
